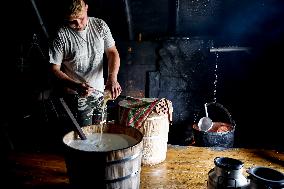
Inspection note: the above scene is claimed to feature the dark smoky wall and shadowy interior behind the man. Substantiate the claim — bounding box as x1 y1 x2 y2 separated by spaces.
1 0 284 150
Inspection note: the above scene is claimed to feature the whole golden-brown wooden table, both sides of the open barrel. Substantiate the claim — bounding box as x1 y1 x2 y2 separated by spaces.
1 145 284 189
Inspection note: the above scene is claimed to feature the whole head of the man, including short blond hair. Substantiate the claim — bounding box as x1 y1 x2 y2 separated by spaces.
64 0 88 31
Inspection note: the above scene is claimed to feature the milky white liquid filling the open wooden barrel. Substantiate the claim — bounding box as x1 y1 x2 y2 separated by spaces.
68 133 137 151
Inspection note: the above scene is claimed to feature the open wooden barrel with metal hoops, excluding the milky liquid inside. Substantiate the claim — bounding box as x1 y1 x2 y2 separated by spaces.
63 124 143 189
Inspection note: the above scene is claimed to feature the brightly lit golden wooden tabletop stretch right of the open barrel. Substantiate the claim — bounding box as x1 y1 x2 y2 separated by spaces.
140 146 284 189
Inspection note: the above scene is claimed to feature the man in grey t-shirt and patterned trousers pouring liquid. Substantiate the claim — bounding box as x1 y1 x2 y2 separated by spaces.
49 0 121 126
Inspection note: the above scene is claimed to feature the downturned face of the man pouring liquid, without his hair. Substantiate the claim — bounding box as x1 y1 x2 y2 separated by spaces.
67 4 88 31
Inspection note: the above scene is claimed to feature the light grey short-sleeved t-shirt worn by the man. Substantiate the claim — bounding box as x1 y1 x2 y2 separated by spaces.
49 17 115 93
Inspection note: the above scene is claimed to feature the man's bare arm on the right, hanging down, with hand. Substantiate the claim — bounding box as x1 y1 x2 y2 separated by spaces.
106 46 121 99
